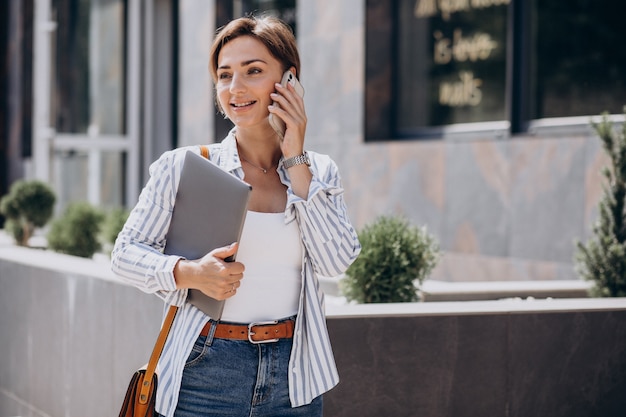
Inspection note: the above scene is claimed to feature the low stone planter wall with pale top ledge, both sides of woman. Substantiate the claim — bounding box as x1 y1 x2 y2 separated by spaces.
0 245 626 417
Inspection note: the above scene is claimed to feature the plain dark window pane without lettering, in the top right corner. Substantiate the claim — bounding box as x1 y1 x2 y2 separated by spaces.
532 0 626 119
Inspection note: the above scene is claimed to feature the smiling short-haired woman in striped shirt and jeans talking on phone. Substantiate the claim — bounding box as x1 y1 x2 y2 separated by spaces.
112 17 360 417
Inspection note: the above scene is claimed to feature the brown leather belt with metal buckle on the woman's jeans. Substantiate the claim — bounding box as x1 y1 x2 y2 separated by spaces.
200 320 294 344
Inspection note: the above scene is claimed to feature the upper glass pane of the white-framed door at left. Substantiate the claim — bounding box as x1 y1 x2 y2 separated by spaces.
51 0 126 134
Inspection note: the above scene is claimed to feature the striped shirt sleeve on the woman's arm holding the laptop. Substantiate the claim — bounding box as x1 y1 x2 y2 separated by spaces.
111 151 187 306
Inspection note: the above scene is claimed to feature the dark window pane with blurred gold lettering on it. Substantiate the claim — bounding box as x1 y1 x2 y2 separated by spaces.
395 0 509 135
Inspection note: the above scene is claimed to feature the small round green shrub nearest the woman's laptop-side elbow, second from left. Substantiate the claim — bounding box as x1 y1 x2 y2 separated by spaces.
48 203 104 258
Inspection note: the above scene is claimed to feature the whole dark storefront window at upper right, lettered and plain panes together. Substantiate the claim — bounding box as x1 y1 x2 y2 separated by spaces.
365 0 626 140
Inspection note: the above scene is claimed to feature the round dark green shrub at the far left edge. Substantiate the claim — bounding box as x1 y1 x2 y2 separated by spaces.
0 180 56 246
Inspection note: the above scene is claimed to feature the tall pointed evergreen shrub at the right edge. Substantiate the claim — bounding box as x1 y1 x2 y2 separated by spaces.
574 108 626 297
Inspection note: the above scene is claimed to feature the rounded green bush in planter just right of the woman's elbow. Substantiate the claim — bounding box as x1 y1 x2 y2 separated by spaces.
341 216 440 303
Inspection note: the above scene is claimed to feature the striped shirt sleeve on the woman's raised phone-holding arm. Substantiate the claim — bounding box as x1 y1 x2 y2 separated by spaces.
287 155 361 277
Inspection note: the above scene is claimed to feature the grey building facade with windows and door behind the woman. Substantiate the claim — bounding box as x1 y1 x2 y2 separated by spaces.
0 0 626 281
